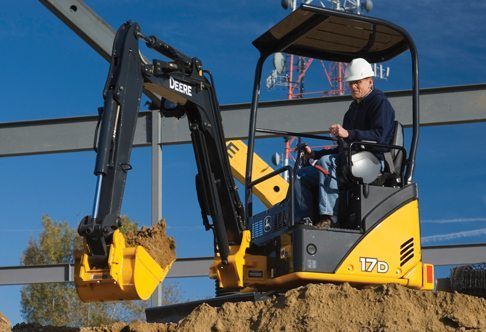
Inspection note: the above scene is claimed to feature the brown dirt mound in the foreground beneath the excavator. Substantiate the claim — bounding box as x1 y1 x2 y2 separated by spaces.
8 284 486 332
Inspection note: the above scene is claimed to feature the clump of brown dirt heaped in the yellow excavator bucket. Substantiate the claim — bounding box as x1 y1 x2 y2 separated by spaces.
125 219 176 268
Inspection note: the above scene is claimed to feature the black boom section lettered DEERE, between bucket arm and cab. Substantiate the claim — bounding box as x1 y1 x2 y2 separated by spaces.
141 29 244 261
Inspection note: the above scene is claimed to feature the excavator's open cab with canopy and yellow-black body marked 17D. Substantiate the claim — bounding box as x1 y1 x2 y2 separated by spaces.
212 5 434 292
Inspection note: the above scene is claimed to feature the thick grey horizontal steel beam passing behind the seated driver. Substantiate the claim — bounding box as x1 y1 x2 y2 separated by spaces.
0 84 486 157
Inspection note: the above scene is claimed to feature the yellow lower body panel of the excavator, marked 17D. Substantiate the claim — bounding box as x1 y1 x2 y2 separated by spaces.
215 200 434 292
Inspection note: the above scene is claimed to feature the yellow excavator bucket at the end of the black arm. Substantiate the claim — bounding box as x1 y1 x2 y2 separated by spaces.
75 230 173 302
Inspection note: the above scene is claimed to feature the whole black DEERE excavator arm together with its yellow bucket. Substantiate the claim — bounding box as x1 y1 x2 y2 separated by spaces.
75 22 244 301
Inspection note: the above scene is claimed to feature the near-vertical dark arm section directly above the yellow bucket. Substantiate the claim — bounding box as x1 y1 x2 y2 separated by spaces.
78 25 143 260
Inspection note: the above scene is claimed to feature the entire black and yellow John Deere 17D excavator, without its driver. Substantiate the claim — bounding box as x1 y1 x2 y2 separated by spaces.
75 5 434 320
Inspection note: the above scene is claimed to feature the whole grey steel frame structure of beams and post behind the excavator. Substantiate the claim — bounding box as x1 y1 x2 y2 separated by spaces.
0 0 486 290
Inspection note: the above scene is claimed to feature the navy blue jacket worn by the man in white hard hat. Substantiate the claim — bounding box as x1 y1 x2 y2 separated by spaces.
315 89 395 159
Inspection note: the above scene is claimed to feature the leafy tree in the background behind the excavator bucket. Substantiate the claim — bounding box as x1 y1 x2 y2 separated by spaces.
21 216 179 326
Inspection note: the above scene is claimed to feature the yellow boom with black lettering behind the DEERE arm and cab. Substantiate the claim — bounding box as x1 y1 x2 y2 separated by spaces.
226 140 289 208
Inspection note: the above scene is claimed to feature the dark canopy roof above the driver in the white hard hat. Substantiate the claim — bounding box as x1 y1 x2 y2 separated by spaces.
253 5 413 63
